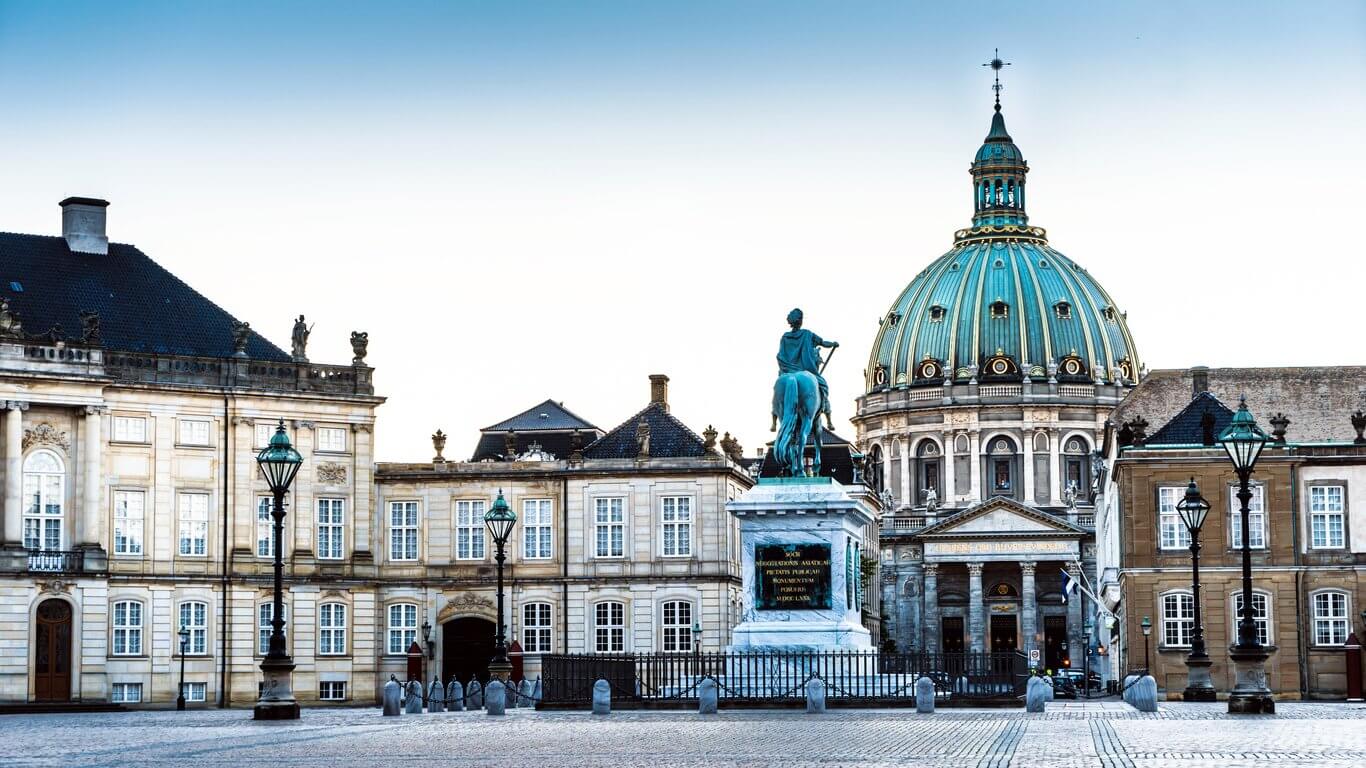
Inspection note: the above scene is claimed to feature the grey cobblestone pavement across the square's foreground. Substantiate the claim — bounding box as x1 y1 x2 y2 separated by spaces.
0 702 1366 768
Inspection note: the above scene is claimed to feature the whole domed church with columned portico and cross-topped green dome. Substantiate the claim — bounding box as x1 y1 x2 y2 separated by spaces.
854 77 1142 668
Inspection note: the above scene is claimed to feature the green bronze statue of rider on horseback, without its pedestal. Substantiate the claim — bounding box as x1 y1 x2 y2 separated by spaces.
769 309 840 477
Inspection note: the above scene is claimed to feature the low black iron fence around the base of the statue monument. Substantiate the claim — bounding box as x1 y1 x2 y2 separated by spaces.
541 650 1029 708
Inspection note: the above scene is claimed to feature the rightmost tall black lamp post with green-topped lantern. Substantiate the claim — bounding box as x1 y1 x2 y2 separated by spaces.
1218 398 1276 715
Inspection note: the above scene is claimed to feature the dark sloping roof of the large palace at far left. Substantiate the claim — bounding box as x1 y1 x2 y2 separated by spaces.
0 232 290 362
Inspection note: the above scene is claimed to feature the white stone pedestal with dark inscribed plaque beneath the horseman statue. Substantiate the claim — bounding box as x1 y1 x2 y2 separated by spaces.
725 477 877 645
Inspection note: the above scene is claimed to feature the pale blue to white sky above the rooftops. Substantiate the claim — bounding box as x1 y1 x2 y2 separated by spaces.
0 0 1366 461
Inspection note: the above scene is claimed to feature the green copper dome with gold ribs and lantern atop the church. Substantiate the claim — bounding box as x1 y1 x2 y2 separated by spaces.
866 105 1141 392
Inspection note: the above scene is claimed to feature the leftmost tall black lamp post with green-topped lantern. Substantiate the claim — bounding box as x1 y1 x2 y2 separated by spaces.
254 418 303 720
